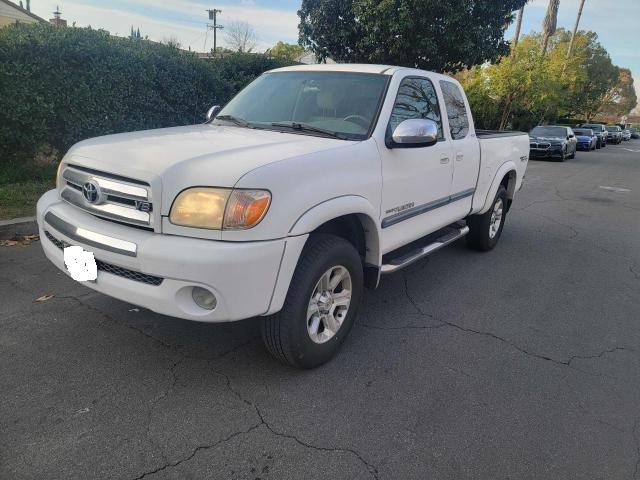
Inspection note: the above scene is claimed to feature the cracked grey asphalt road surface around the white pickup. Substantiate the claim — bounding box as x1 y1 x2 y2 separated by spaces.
0 140 640 480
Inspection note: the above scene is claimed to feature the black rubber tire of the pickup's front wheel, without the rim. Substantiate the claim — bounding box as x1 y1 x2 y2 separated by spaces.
262 234 364 368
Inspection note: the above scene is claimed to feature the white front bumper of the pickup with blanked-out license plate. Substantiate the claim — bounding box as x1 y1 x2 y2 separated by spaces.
37 190 307 322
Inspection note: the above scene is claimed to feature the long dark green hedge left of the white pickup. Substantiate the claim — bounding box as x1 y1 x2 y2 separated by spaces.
0 24 284 181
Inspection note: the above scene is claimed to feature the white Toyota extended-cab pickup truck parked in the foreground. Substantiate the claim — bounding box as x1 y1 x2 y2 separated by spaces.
37 65 529 368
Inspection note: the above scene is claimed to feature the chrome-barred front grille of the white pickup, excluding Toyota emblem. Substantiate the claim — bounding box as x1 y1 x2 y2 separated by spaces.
60 165 153 227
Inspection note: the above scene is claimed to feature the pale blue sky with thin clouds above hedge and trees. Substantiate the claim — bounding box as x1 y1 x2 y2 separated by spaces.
22 0 640 113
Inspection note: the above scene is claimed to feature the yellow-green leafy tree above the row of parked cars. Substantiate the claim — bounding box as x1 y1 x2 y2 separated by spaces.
458 29 634 130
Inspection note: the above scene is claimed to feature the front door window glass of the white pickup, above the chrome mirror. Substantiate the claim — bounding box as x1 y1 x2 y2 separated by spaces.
389 77 444 140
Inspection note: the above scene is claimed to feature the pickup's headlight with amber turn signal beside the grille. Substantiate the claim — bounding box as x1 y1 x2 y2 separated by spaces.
169 187 271 230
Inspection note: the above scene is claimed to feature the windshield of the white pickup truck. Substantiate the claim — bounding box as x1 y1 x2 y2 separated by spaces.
218 71 389 140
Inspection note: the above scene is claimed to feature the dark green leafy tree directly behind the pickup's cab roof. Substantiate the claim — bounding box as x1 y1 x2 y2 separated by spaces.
298 0 526 71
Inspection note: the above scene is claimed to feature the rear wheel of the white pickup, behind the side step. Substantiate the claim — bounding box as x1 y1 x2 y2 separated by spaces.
467 185 507 252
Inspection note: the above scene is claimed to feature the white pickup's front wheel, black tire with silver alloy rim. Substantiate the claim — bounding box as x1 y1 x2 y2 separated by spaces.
262 234 363 368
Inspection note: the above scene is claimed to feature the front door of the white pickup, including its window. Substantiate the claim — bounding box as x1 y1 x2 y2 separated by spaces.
381 76 454 253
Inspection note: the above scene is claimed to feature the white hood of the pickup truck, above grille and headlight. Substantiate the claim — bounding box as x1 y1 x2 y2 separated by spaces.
65 124 352 188
